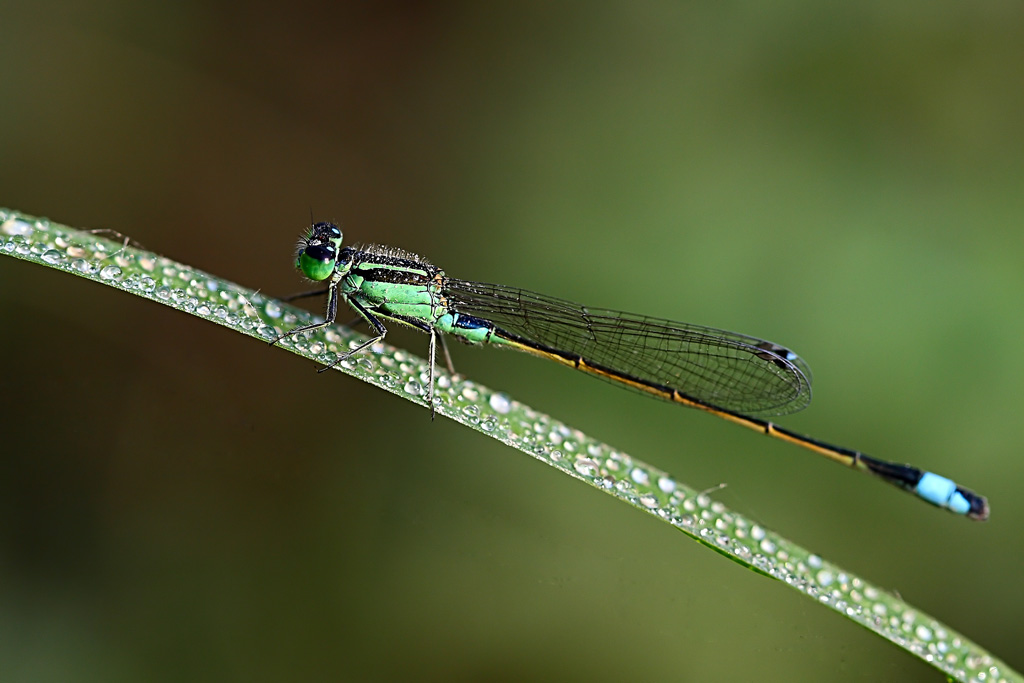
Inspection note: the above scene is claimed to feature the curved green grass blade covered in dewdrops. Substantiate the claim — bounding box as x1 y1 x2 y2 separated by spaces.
0 209 1024 681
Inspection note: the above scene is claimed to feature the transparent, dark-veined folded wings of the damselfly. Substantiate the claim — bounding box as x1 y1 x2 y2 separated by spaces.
444 279 811 416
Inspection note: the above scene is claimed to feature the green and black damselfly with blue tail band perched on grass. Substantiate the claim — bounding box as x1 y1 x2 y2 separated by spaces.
270 222 988 519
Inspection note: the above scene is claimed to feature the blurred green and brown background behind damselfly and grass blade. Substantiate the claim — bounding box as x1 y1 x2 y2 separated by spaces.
0 1 1024 681
